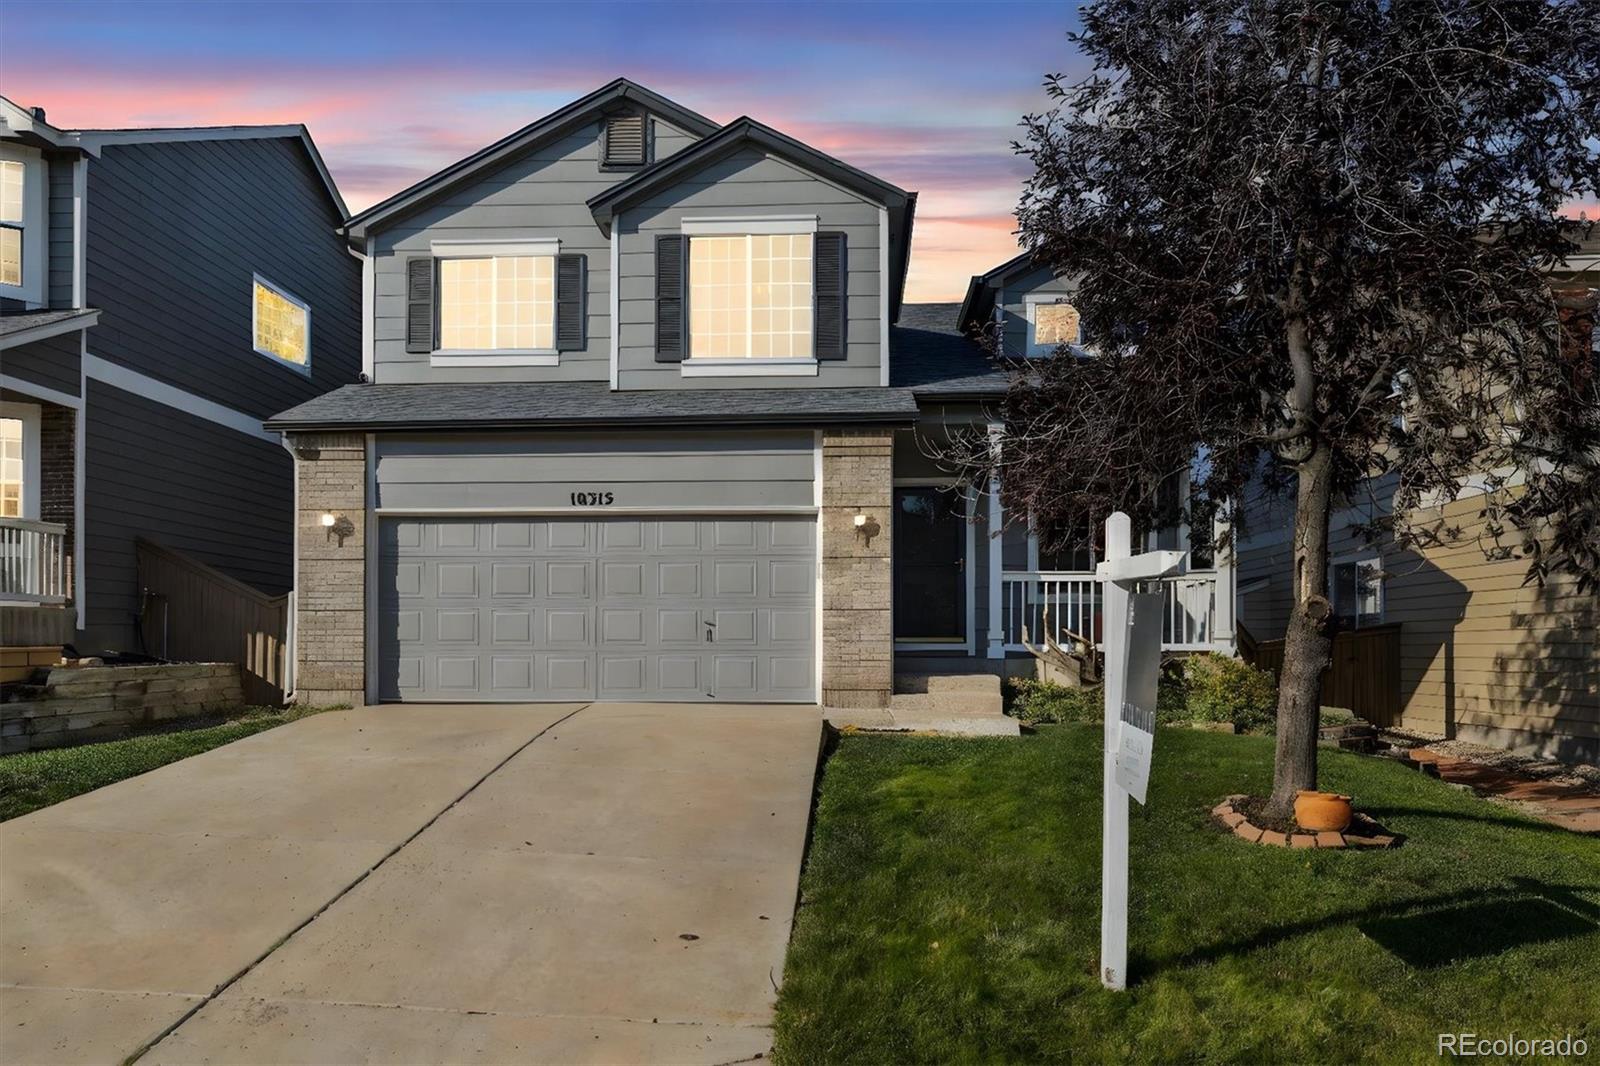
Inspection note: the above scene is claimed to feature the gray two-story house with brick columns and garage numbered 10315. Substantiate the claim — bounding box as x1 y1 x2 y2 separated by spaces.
267 80 1232 706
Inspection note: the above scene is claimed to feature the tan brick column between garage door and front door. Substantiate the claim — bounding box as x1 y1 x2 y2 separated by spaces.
821 429 894 707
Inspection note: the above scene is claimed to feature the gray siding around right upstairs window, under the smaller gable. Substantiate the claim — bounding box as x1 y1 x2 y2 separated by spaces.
616 147 882 389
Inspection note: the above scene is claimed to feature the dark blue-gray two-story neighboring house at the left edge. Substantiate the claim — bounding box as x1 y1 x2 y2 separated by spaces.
0 98 362 653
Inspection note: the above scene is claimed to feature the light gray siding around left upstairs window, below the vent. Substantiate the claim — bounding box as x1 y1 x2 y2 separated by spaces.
373 118 694 384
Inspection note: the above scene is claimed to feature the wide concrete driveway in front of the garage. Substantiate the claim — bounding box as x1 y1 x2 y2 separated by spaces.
0 704 821 1063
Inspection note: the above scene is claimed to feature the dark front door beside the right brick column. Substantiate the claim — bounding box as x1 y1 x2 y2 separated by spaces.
894 485 966 643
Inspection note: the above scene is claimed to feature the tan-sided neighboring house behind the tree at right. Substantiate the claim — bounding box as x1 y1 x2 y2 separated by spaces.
1237 224 1600 763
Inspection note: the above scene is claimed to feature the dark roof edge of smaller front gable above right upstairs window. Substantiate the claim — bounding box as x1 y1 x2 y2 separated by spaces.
589 115 917 322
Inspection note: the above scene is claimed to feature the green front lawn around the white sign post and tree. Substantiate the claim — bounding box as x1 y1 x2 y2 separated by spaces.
776 725 1600 1064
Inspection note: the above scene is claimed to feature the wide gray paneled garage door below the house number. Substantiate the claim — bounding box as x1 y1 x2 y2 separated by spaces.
378 517 816 701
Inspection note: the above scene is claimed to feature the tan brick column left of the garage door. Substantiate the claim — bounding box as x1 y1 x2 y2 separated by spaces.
290 434 366 707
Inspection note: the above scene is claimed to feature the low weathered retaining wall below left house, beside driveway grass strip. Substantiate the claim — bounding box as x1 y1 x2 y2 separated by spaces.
0 659 245 754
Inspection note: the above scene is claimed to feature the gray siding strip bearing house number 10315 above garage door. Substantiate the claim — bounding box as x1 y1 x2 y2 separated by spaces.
378 431 816 512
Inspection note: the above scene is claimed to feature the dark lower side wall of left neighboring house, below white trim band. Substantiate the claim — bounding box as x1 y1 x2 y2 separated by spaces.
78 381 294 651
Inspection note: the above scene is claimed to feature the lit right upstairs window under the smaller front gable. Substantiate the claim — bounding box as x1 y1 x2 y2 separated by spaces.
690 234 811 359
